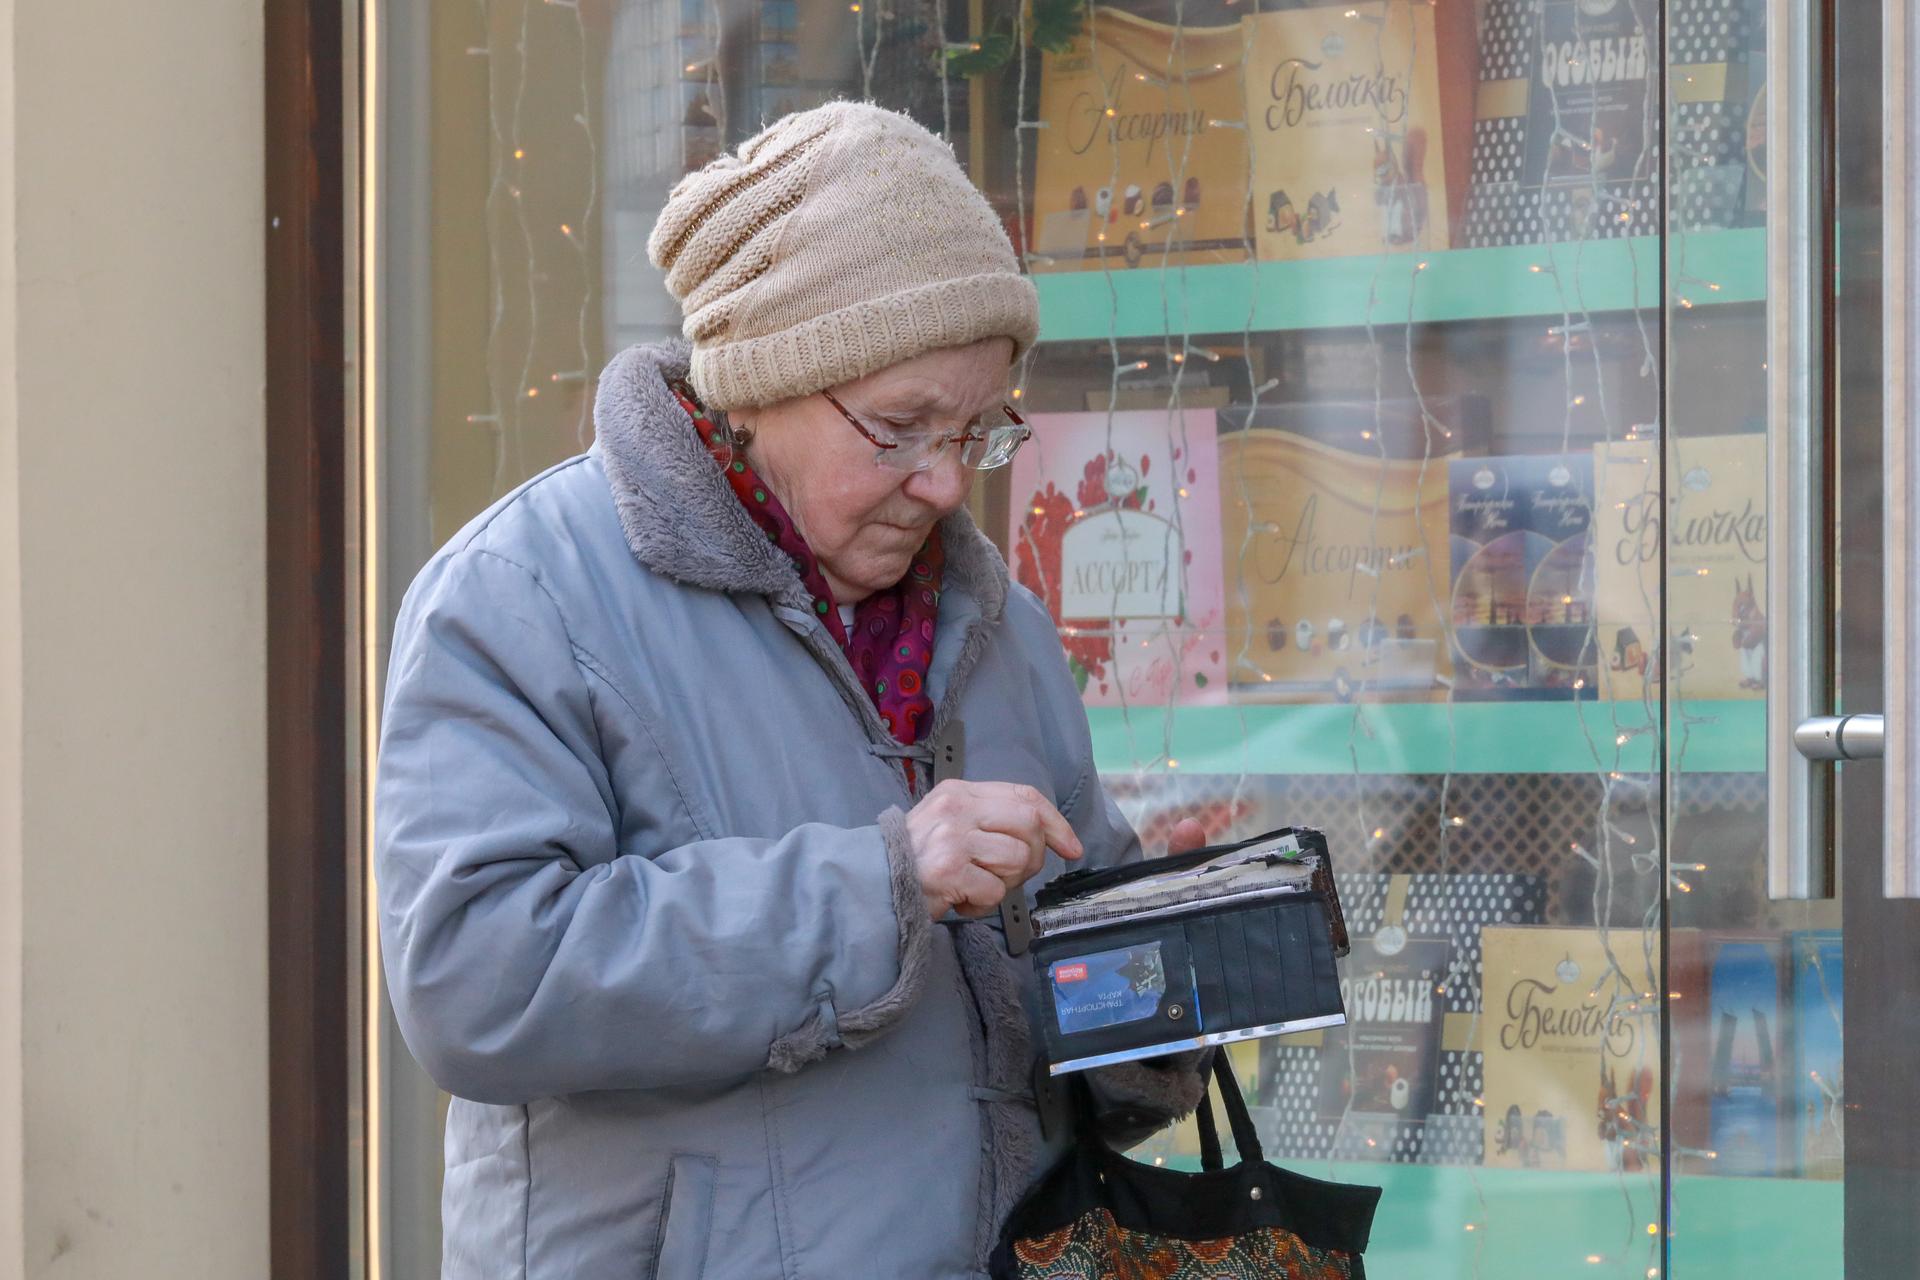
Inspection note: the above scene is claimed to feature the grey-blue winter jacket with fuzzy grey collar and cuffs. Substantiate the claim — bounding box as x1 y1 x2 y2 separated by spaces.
376 347 1196 1280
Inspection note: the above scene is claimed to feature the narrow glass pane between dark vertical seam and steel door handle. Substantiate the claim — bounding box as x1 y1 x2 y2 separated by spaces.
1661 0 1850 1280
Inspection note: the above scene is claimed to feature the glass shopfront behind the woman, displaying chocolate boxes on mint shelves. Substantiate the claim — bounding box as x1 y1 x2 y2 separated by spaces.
363 0 1920 1280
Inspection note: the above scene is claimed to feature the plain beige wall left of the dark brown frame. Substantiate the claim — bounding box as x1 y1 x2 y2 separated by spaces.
0 0 269 1280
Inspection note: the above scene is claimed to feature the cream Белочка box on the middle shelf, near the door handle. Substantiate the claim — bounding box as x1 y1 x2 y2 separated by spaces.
1594 434 1766 702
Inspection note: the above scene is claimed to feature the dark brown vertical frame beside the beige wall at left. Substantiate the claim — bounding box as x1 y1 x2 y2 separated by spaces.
263 0 355 1280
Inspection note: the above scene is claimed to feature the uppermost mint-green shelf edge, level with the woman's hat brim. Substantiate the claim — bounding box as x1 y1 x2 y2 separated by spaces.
1033 228 1766 342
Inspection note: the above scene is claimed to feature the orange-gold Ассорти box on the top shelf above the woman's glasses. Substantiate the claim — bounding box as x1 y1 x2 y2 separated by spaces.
1031 8 1248 271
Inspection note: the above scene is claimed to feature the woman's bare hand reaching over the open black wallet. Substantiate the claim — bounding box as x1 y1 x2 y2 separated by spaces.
906 777 1085 919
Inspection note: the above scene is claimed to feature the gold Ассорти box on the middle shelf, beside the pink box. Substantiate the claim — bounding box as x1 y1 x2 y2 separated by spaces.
1219 397 1486 700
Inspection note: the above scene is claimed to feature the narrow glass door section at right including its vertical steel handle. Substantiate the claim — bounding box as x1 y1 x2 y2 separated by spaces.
1657 4 1843 1276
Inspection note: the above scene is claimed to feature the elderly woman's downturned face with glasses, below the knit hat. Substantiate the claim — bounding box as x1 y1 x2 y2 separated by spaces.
733 338 1014 604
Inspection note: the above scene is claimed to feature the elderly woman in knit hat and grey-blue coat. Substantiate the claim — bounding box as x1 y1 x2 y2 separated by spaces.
376 104 1200 1280
